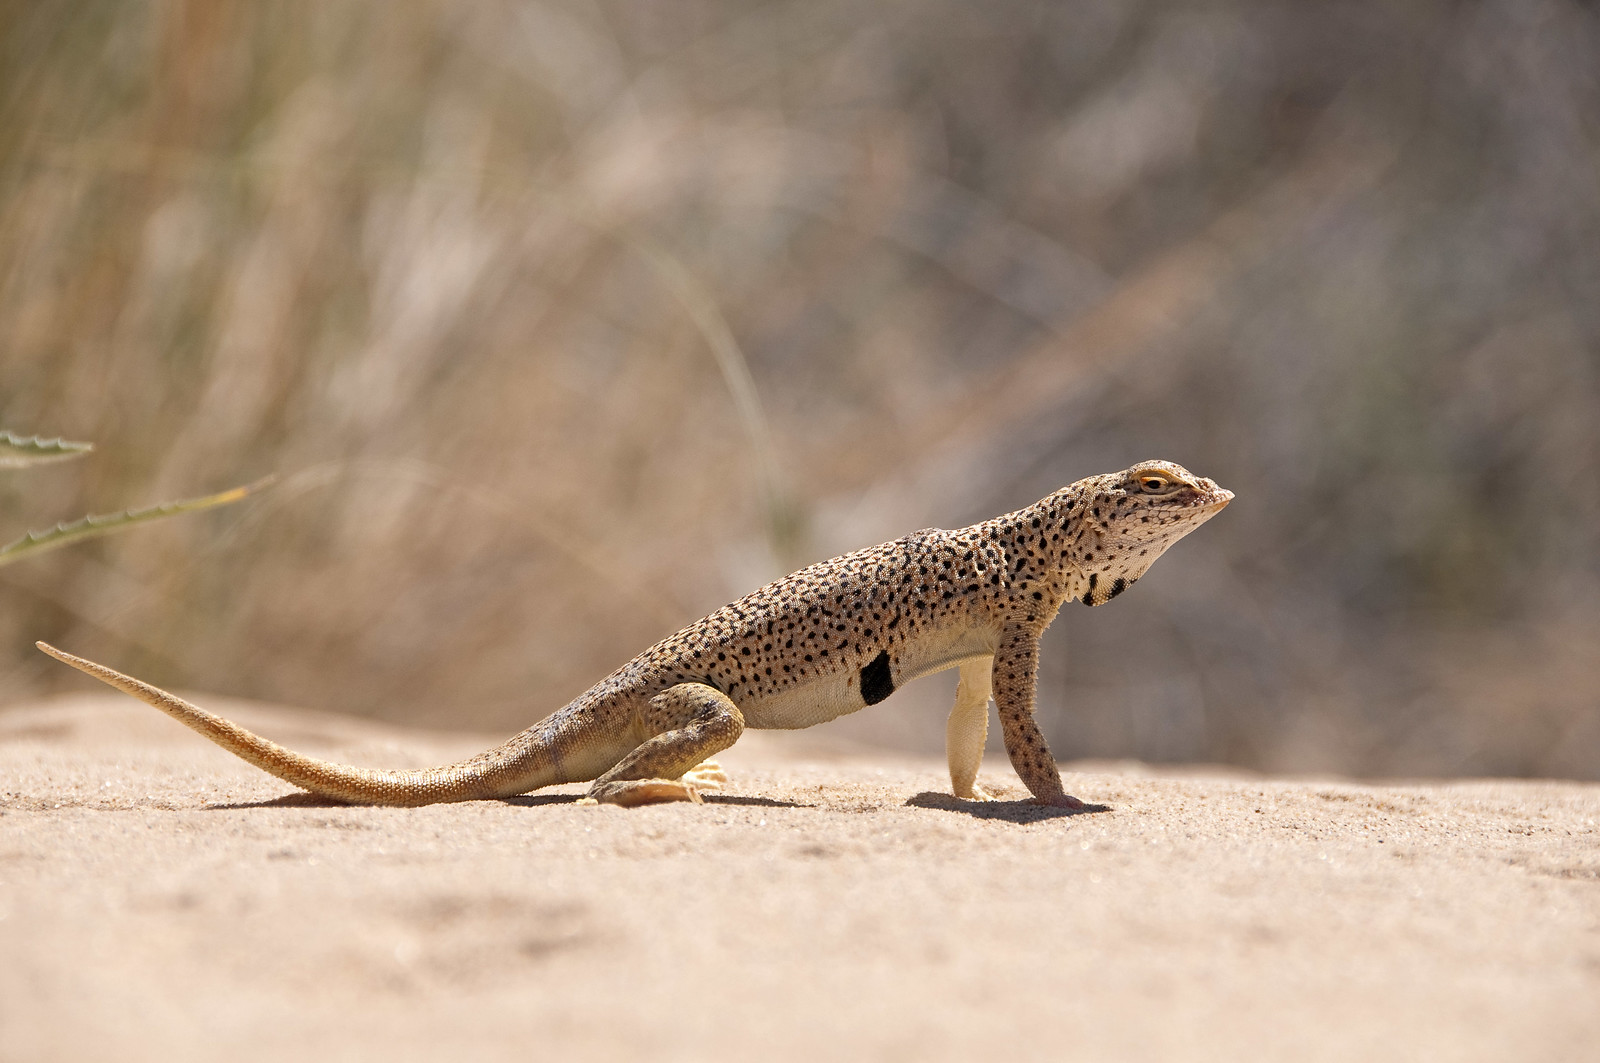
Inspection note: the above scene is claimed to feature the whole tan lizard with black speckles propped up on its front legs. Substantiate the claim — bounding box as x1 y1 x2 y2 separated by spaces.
37 461 1234 808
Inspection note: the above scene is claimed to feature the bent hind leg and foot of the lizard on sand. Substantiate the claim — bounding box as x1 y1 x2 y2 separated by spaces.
584 684 744 805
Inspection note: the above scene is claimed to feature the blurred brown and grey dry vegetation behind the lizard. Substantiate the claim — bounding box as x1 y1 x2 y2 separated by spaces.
0 0 1600 780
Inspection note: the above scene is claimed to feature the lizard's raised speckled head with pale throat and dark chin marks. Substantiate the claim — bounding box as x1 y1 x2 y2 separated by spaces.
1067 461 1234 605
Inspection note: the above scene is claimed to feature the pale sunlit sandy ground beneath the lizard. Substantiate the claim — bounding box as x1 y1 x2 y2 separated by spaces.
0 695 1600 1060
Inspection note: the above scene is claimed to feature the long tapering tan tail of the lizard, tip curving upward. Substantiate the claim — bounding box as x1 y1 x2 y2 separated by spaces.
34 642 566 807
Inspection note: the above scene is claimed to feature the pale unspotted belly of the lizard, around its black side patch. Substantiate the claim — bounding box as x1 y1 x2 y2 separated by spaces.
739 629 995 730
